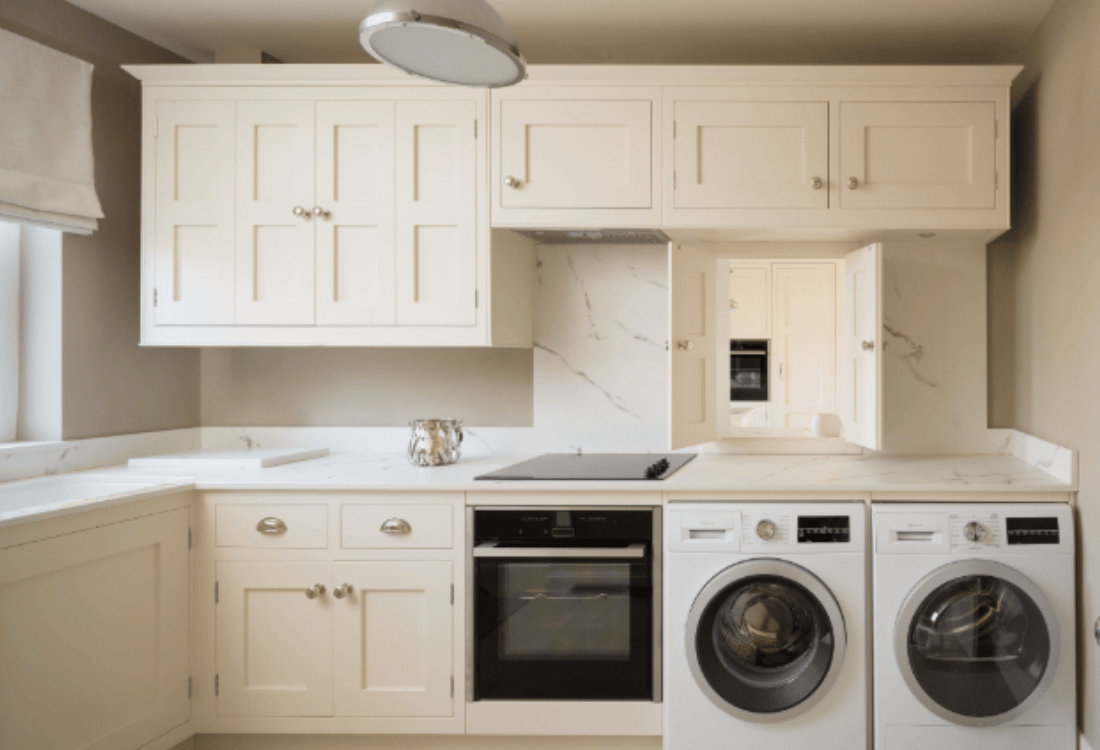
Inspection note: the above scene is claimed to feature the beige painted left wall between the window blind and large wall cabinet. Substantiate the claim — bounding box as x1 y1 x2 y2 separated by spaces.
0 0 199 439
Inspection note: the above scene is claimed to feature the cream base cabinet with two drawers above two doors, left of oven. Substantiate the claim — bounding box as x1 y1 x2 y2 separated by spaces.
197 492 465 734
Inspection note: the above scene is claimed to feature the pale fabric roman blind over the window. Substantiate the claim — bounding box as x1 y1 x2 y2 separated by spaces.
0 29 103 234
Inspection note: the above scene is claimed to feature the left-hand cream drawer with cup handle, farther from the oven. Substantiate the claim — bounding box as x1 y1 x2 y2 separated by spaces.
215 505 329 549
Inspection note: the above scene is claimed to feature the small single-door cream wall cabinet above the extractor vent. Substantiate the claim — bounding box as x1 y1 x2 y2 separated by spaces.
490 86 660 228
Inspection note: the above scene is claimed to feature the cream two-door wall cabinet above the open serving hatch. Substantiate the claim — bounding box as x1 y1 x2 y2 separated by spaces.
662 66 1020 237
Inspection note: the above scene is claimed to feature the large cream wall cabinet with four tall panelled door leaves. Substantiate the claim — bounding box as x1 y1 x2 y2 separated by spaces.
132 66 534 346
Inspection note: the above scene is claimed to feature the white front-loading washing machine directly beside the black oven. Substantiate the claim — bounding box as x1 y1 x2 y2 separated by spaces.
663 503 869 750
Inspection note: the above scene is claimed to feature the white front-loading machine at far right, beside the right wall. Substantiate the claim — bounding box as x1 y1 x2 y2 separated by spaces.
872 504 1077 750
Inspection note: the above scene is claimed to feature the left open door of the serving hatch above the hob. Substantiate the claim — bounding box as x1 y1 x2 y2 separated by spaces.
669 244 729 449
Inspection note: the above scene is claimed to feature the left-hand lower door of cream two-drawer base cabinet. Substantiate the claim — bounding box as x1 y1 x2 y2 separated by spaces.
217 561 332 716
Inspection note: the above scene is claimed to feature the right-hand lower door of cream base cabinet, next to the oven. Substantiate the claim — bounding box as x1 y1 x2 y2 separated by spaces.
334 562 454 717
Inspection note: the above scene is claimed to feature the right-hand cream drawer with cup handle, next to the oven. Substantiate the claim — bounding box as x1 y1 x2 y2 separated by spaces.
340 504 454 550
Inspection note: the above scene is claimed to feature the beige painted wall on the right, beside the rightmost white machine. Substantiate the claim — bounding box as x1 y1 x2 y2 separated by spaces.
990 0 1100 748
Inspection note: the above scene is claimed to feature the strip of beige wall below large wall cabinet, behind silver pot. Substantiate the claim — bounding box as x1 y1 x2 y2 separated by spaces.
202 349 534 427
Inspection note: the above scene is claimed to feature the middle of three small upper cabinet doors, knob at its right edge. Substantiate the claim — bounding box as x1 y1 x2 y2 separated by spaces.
674 101 828 208
